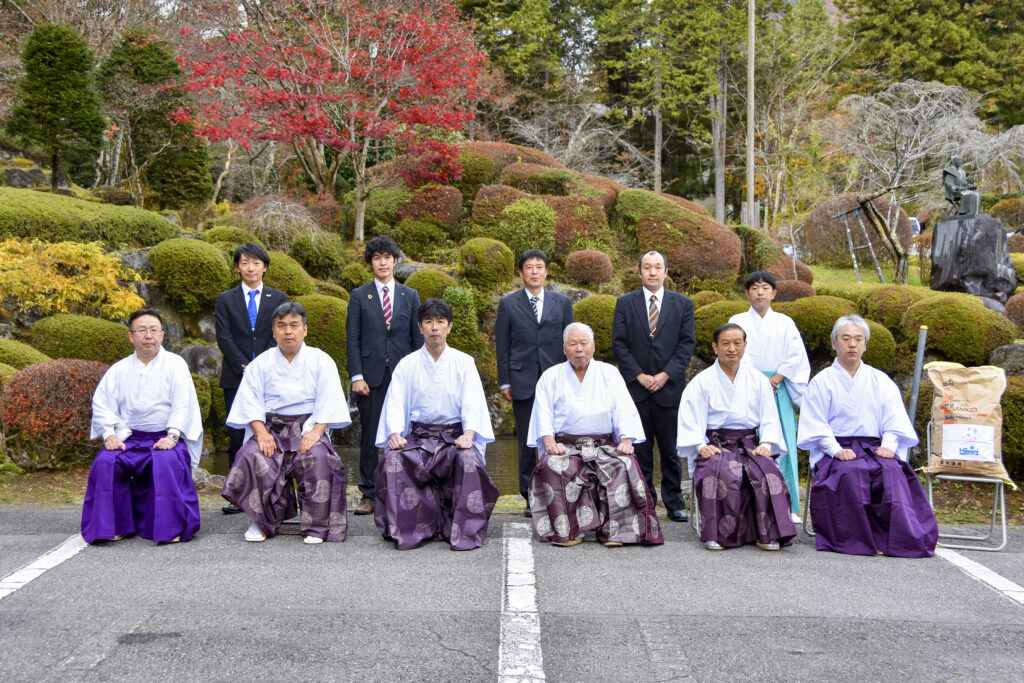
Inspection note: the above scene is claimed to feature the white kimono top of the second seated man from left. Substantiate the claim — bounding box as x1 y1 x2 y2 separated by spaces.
227 343 352 440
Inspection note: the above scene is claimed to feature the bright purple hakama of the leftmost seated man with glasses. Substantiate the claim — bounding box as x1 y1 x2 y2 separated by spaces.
82 431 199 543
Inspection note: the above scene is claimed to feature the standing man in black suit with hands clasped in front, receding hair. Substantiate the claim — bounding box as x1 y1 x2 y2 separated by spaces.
611 251 696 521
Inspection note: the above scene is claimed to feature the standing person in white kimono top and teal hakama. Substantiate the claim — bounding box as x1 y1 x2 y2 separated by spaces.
729 270 811 513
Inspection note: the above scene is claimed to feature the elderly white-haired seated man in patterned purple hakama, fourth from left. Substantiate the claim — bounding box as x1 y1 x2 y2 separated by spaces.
526 323 664 548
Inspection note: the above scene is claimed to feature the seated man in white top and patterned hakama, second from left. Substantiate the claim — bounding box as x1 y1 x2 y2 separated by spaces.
221 301 351 544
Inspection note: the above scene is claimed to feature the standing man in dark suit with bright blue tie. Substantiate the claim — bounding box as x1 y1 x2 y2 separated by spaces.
213 242 288 514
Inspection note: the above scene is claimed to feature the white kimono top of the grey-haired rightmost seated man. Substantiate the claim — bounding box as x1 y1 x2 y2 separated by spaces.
797 360 918 467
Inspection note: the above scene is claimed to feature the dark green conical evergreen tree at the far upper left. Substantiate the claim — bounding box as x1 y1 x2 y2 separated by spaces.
6 24 106 189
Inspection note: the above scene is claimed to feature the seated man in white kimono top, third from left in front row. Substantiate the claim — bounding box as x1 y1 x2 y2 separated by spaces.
374 298 498 550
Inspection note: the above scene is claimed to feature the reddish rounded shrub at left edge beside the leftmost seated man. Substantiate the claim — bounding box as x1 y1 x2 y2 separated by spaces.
0 358 108 469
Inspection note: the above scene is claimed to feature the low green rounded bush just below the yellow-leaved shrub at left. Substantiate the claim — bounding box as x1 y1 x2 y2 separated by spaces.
32 313 135 365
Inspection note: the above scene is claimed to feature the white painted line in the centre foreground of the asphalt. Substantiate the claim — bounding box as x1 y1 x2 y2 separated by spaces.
498 523 546 683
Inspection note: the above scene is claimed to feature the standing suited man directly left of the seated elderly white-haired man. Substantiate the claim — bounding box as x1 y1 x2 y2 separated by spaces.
495 249 572 517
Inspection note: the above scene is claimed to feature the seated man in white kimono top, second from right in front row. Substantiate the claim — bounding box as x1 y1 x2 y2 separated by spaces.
677 323 797 550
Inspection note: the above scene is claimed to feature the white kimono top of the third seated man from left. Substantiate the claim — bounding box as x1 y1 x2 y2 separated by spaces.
376 346 495 461
